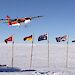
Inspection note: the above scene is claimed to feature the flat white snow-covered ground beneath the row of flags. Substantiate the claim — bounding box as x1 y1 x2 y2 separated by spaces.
0 43 75 75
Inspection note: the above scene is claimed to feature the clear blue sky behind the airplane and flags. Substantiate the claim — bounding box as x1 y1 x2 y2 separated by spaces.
0 0 75 43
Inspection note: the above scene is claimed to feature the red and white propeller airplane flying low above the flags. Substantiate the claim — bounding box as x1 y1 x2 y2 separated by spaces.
0 16 43 26
